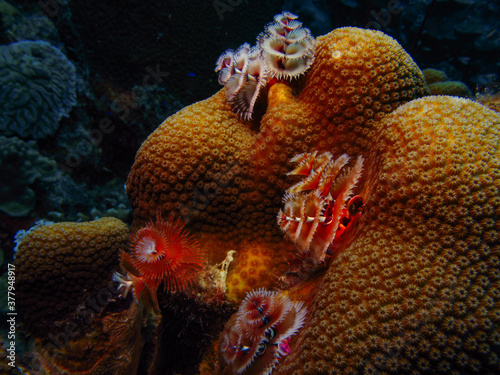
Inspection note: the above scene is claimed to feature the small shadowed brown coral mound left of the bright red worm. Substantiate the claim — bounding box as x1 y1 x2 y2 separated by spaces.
14 218 128 330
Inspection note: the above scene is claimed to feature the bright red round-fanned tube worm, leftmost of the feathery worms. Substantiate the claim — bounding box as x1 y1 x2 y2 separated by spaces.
118 217 206 306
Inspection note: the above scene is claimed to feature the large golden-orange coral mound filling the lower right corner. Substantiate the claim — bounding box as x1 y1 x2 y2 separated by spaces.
277 96 500 374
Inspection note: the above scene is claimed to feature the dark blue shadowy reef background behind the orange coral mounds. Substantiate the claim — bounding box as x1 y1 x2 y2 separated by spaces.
0 0 500 372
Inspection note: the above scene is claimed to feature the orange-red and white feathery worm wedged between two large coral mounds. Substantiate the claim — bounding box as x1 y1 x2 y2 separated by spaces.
278 152 364 263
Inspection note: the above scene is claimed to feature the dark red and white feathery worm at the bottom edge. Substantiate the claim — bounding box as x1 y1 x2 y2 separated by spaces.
219 288 307 375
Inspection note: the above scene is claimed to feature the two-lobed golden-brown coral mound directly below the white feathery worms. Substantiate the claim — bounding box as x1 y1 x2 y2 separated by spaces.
127 28 427 247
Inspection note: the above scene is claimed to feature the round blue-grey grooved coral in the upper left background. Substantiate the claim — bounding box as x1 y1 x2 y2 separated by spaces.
0 41 76 138
